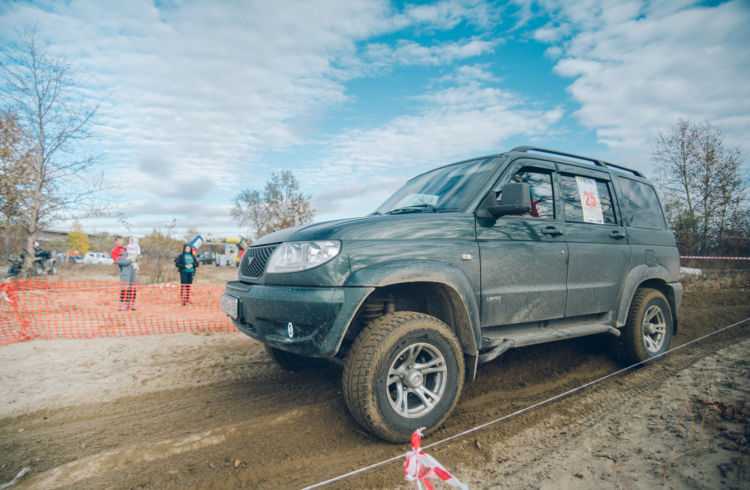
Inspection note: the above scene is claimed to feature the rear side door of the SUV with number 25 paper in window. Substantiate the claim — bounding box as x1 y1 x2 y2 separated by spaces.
558 164 630 317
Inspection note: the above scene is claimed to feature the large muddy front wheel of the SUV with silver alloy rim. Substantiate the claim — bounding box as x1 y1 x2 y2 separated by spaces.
343 312 464 442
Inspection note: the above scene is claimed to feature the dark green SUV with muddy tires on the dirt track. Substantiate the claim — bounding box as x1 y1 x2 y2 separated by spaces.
222 147 682 442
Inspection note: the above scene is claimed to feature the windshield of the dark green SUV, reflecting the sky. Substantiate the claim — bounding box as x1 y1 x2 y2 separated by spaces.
374 158 497 214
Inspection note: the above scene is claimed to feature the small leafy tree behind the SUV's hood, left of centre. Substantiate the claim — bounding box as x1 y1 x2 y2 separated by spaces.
231 170 315 238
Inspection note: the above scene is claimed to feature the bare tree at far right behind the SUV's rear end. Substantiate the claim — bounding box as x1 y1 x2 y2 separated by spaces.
652 119 746 254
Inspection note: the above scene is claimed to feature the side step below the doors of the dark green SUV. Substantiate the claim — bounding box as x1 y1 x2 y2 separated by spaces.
479 323 620 363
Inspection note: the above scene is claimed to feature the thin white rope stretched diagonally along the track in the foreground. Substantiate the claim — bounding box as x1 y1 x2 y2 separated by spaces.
303 318 750 490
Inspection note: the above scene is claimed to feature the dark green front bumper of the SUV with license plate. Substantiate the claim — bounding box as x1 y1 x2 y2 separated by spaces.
222 281 374 357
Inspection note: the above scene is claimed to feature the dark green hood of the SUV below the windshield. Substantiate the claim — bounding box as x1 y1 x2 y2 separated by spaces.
253 213 474 247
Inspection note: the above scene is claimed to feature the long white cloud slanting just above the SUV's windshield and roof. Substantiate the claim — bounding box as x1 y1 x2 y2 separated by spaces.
302 80 563 220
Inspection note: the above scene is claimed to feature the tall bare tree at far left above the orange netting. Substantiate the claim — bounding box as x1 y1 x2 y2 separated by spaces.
0 30 101 272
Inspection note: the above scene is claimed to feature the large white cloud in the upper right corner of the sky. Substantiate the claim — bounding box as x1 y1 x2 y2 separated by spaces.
541 1 750 155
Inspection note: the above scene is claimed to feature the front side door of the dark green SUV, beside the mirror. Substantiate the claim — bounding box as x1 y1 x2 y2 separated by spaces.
477 159 567 326
